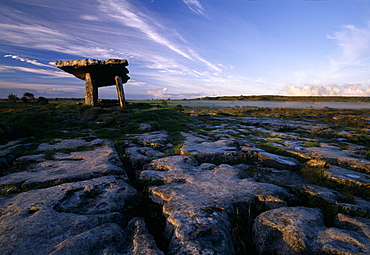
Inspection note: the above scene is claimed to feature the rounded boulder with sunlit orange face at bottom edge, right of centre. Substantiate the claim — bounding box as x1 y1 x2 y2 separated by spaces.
253 207 324 255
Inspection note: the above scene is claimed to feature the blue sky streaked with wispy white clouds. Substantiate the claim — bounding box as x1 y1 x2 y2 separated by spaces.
0 0 370 99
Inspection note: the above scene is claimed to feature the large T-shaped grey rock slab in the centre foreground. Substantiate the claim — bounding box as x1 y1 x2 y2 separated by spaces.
140 156 292 254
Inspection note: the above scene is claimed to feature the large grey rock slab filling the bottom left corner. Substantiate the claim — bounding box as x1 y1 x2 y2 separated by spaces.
0 176 137 254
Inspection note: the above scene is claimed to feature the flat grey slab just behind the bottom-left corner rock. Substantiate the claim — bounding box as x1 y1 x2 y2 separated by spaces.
0 139 127 190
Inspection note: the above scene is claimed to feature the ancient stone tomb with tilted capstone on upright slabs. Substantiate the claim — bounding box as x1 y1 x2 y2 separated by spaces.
55 59 130 107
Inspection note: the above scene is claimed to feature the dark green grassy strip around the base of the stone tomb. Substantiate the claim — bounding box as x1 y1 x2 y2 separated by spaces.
0 102 190 144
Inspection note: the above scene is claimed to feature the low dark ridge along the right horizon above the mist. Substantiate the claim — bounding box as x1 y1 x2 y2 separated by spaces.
197 95 370 103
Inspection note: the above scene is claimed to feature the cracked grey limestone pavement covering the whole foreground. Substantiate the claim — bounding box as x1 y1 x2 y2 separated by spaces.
0 112 370 255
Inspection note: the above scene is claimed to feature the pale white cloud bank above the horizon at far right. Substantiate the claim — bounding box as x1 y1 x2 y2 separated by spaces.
289 23 370 87
